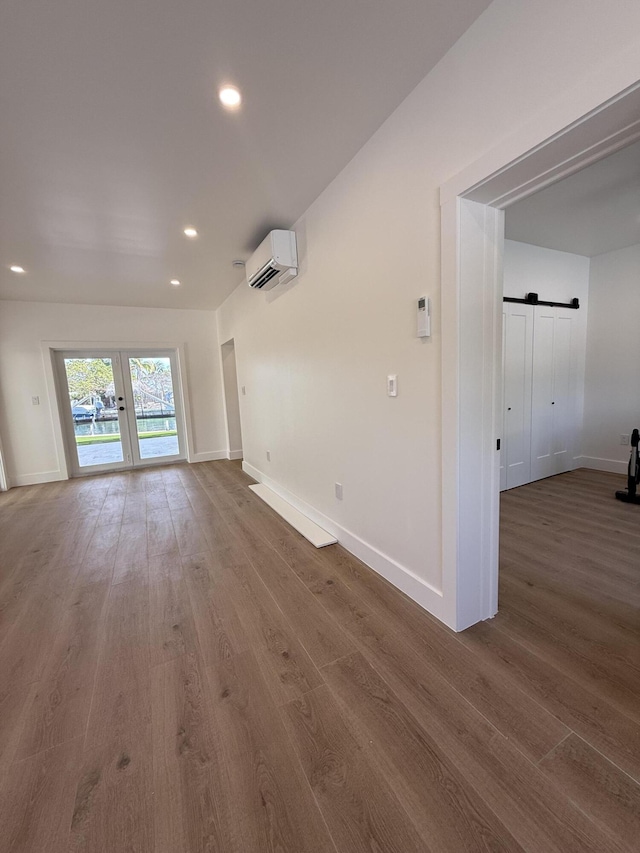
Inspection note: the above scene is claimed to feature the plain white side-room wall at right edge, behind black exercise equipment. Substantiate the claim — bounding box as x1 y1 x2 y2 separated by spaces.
583 244 640 473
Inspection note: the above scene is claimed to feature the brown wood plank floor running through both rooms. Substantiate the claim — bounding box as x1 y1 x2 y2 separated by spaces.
0 462 640 853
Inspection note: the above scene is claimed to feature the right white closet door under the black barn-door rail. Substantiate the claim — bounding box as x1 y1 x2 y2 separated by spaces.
531 307 575 480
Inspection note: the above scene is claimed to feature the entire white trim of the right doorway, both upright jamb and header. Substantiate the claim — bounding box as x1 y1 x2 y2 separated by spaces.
440 76 640 631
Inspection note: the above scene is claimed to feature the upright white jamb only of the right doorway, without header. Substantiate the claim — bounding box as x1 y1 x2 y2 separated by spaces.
441 199 504 631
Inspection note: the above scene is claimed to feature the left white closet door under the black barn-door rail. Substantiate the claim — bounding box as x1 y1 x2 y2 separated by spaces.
501 302 533 489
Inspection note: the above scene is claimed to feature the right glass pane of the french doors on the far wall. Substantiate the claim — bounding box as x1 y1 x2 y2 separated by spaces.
129 356 180 460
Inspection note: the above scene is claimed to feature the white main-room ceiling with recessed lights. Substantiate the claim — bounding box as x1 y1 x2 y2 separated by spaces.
0 0 489 309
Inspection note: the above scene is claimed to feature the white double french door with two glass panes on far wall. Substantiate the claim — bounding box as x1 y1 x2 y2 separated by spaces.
57 350 185 476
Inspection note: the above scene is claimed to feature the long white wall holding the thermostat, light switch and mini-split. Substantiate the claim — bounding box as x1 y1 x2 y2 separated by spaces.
218 0 640 624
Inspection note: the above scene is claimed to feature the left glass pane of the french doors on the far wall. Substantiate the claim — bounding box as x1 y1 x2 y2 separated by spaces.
63 356 125 468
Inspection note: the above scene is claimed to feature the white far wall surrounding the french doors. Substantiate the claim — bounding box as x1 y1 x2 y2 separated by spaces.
0 301 226 485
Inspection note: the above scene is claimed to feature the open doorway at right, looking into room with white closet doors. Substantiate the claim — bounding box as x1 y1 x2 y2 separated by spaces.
492 135 640 664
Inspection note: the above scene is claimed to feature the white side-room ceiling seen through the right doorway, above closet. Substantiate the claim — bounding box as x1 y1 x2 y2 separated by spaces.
505 136 640 257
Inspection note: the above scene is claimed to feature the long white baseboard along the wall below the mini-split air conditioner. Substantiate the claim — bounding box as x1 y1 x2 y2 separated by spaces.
242 461 444 630
